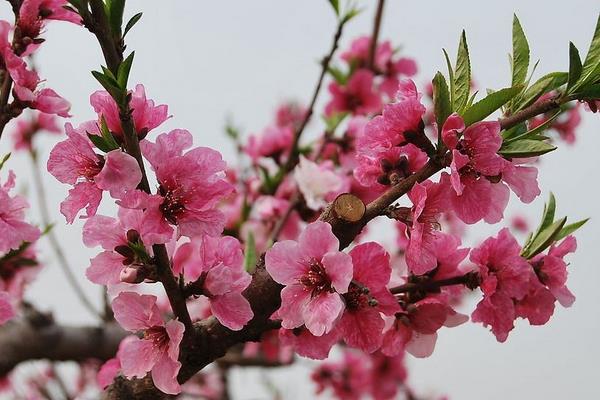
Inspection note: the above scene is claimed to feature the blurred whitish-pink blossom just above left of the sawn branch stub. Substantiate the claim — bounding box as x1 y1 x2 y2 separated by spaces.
294 156 344 211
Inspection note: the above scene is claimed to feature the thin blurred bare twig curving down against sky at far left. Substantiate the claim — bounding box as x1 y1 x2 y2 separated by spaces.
29 150 103 319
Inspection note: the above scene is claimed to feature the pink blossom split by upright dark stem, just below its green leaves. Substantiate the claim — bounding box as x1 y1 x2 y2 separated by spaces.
90 84 169 139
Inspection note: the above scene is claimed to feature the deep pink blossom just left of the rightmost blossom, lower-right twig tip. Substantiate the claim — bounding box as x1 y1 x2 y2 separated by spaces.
470 228 535 342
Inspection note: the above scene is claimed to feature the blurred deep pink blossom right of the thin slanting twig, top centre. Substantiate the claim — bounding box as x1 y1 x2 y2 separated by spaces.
325 69 381 116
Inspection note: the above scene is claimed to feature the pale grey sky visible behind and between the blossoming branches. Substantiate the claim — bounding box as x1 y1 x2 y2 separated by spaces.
0 0 600 400
